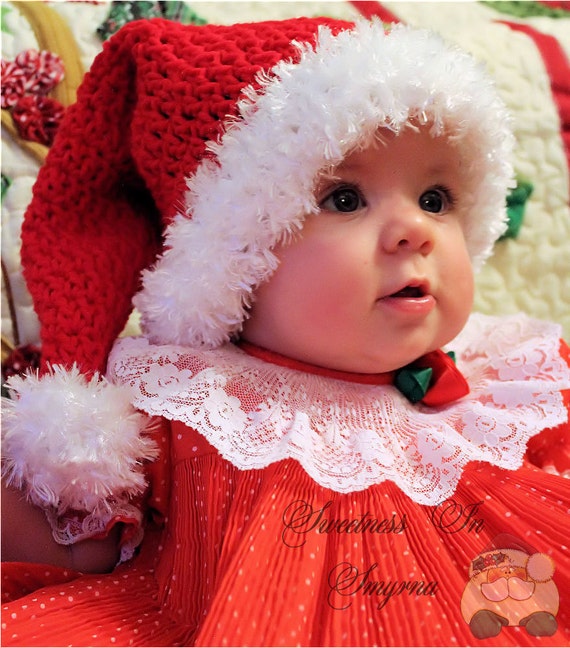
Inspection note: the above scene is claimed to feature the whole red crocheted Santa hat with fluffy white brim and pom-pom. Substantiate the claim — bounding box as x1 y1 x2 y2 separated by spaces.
1 18 512 506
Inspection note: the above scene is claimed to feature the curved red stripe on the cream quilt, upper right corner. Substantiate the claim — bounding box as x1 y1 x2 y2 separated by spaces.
499 20 570 172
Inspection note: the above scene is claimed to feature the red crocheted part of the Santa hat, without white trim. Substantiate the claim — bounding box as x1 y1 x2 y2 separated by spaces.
22 18 350 375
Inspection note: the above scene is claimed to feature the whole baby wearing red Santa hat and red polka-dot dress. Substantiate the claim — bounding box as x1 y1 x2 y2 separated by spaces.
3 19 570 645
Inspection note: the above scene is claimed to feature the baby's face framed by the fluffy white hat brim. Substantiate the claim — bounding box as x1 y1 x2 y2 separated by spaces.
243 129 473 373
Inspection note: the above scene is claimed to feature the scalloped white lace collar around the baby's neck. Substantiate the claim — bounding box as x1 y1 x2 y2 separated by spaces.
109 315 570 505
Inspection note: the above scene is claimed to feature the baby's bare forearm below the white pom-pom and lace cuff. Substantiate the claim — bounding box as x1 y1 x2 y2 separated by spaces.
2 482 121 572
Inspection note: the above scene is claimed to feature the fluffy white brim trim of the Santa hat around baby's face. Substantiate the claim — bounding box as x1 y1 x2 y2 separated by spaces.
135 21 513 348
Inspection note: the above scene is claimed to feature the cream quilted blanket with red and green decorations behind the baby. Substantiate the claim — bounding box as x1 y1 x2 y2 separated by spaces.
1 0 570 370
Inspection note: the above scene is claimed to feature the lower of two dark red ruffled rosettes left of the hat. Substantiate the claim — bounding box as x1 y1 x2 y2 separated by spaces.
12 95 65 146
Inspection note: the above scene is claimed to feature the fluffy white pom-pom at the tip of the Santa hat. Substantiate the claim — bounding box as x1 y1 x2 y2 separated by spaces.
2 366 157 513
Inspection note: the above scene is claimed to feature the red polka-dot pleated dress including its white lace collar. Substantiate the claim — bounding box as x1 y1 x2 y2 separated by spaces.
2 312 570 646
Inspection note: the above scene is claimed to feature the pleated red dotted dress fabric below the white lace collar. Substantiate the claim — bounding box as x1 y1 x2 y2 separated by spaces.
2 423 570 646
